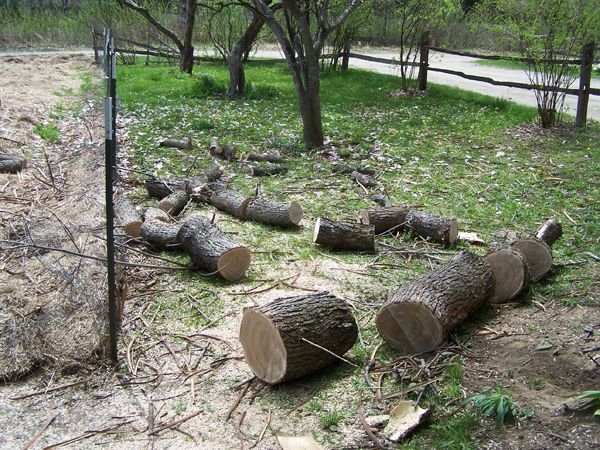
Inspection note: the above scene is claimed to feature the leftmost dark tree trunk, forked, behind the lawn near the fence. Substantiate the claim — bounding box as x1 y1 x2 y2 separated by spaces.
118 0 198 74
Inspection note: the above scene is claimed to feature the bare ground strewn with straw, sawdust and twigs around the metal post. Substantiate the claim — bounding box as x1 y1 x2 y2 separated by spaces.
0 52 600 449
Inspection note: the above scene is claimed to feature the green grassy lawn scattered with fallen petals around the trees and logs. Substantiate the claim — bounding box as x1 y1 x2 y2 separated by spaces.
118 59 600 448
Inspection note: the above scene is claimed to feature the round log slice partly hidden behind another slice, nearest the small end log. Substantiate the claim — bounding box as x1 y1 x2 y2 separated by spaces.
490 230 552 281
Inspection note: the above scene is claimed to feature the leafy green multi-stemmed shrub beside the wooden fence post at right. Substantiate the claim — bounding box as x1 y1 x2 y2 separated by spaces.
475 0 600 128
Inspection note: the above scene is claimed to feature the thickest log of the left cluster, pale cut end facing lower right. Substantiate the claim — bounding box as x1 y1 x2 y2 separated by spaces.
177 217 250 281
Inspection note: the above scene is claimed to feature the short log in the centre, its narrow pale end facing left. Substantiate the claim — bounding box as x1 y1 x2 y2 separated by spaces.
313 217 375 252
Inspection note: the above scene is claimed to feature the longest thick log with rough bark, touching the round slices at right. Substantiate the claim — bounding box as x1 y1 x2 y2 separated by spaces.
375 252 494 354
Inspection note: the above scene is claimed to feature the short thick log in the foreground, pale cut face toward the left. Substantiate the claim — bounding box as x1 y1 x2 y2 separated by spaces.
240 292 358 384
